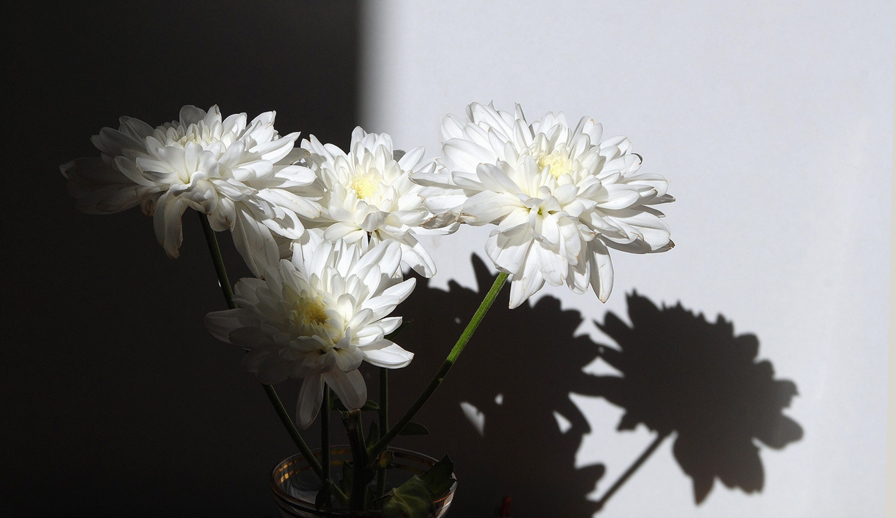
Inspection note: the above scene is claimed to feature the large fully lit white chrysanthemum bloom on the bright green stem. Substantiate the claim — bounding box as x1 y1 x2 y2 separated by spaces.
413 103 673 308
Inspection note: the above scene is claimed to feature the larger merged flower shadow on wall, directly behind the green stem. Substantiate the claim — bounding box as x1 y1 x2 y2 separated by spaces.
389 255 605 518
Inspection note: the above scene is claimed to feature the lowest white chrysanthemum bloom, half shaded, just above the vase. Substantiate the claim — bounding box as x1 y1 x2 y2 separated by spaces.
205 236 415 428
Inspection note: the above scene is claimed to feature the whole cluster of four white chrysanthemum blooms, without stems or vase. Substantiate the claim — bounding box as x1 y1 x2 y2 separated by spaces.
62 104 672 427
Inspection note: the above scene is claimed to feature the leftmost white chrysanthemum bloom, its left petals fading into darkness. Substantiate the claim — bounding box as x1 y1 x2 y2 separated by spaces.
61 106 320 275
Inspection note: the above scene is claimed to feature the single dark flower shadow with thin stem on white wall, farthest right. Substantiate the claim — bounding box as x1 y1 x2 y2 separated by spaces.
593 293 803 506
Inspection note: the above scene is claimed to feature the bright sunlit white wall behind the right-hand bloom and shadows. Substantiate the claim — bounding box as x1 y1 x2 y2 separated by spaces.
361 0 894 517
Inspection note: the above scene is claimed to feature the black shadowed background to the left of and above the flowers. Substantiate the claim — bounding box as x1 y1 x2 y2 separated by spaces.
0 0 359 516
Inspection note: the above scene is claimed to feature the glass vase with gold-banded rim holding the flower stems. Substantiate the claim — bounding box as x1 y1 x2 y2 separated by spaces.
271 446 457 518
